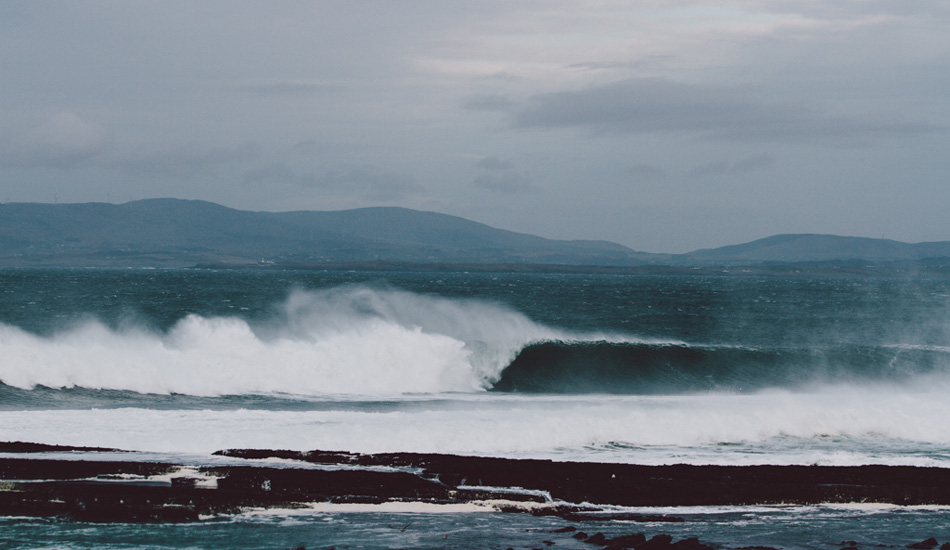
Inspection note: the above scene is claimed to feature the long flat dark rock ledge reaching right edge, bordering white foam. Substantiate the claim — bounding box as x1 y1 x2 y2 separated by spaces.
221 450 950 506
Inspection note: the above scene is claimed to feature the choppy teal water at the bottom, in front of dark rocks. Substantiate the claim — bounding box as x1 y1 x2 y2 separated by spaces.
0 505 950 550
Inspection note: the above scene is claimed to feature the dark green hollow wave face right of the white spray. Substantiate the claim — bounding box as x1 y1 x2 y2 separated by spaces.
493 341 950 394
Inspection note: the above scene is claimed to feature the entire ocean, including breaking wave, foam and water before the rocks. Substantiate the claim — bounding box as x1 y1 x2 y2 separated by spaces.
0 268 950 549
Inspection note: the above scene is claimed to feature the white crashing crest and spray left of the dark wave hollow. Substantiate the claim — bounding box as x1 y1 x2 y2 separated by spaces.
0 286 561 396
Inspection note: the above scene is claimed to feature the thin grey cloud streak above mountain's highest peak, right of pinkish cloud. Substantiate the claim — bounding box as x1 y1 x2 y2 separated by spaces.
117 143 261 177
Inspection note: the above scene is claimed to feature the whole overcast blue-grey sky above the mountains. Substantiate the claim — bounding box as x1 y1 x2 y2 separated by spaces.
0 0 950 253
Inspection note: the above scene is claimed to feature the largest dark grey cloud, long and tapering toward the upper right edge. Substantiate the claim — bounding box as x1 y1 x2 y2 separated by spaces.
512 78 936 141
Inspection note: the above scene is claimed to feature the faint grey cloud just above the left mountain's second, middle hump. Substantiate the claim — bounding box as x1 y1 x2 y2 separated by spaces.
301 167 424 202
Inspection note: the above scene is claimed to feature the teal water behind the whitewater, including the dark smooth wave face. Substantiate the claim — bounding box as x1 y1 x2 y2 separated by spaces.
0 269 950 402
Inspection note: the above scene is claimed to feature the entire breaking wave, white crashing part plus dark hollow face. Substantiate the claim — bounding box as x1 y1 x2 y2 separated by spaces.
0 286 950 396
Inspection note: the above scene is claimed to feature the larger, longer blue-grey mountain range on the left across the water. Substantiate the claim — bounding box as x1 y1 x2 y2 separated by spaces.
0 199 650 266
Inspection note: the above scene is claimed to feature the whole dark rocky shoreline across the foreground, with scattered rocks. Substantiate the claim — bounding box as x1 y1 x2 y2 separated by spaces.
0 442 950 550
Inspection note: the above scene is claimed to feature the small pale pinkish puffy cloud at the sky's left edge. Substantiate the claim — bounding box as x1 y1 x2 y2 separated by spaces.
0 112 109 168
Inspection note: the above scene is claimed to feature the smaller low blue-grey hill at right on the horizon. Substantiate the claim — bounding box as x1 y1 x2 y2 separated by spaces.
675 234 950 265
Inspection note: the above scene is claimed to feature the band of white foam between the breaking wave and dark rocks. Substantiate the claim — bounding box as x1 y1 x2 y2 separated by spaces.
0 389 950 467
